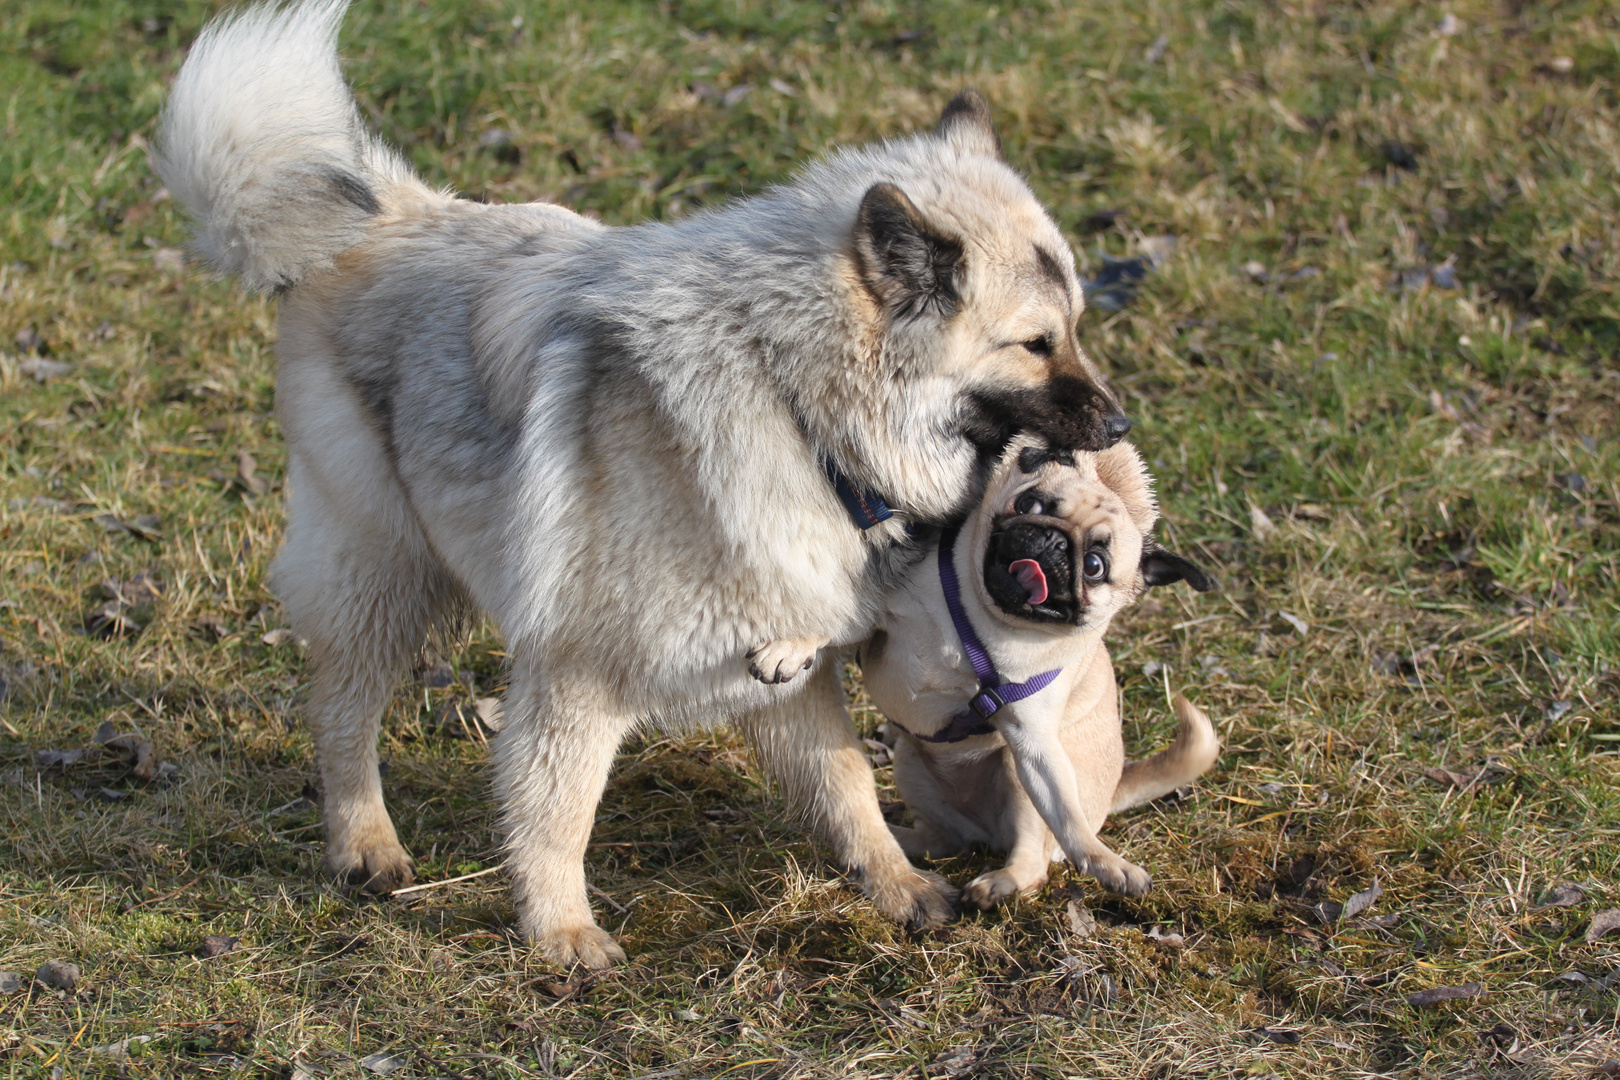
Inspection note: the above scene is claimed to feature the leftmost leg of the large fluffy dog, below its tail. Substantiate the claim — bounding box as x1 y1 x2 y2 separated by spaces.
272 458 455 892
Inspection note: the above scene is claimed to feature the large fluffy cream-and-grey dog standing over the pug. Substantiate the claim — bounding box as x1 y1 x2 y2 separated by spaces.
157 0 1128 965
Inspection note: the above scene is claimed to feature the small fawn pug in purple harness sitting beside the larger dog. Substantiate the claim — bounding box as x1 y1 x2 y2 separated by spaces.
862 439 1220 908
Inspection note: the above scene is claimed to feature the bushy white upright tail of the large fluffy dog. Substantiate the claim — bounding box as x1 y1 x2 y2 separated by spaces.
152 0 418 290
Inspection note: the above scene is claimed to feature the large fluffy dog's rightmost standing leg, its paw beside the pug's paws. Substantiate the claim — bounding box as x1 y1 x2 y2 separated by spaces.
739 664 956 926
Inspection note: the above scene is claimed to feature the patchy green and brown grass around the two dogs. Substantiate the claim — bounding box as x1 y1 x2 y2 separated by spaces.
0 0 1620 1078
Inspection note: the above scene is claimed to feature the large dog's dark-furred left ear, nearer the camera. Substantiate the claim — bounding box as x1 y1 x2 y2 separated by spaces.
855 183 962 316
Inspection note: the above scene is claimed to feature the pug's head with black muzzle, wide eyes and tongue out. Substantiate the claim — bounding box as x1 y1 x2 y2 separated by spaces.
982 444 1213 630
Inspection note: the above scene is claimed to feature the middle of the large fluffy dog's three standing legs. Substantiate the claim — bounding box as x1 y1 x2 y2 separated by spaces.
496 672 630 968
